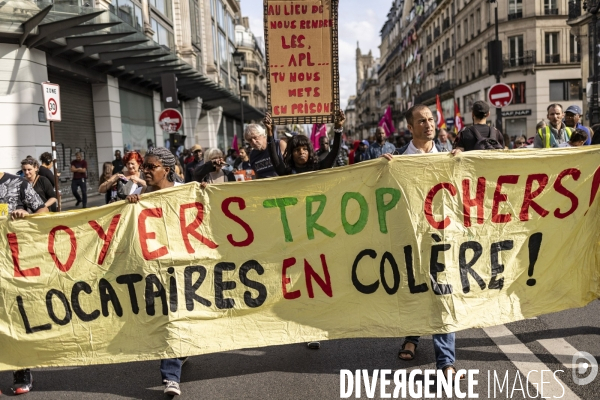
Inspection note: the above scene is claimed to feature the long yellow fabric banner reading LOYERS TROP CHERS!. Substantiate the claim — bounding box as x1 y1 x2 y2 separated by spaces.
0 146 600 370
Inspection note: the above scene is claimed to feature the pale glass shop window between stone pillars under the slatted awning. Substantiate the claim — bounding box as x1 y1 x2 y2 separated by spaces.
119 89 156 156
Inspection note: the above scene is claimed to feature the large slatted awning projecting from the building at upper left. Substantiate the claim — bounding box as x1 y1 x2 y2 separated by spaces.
0 0 264 121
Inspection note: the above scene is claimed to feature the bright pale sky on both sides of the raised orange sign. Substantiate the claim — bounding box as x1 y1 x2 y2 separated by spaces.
240 0 392 109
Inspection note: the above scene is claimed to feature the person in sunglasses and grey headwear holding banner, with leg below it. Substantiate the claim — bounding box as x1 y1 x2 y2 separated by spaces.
126 147 187 396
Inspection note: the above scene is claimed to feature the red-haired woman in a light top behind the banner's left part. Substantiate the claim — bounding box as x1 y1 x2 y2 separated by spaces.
98 151 146 203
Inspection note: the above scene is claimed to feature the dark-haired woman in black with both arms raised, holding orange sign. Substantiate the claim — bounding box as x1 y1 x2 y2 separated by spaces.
263 110 346 176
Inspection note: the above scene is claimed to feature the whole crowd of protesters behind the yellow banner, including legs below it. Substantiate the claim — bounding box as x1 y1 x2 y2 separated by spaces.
0 101 600 395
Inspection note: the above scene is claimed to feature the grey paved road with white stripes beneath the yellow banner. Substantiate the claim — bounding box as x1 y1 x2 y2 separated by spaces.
0 301 600 400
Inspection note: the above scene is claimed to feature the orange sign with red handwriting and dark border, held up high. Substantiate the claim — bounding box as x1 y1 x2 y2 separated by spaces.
264 0 340 124
